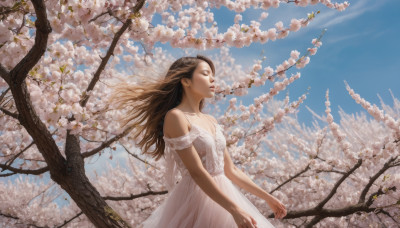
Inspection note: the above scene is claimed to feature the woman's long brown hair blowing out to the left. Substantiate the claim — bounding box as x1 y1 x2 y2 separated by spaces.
104 55 215 161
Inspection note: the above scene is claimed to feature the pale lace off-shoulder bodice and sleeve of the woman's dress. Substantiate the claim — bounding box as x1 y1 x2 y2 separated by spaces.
163 114 226 190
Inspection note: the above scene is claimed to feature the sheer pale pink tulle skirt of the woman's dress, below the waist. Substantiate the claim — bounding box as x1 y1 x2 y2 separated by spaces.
139 173 274 228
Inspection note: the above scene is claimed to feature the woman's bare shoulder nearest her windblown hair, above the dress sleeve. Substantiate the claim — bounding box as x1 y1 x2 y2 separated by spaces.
164 108 189 138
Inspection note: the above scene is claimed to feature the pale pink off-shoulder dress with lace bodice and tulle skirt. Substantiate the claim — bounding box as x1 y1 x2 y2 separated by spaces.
139 112 274 228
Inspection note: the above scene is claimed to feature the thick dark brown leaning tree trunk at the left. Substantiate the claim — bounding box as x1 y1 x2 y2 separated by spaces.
1 0 134 228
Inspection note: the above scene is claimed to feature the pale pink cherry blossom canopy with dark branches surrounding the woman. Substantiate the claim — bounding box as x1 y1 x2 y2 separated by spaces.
0 0 400 227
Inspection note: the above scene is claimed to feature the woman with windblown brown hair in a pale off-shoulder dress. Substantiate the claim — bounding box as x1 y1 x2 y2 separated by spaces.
108 55 286 228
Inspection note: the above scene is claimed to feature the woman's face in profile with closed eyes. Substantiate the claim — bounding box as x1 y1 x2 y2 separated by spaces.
189 61 215 98
